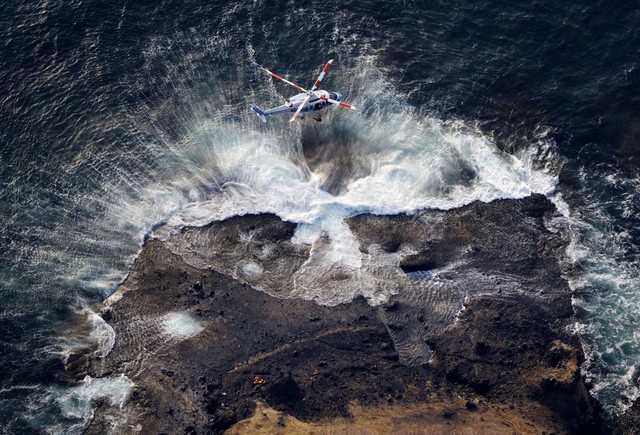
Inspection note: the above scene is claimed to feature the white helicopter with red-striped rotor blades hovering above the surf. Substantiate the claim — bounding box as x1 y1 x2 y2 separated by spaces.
251 59 356 122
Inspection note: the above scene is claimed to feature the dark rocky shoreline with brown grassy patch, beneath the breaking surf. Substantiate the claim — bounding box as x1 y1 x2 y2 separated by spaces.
68 195 599 434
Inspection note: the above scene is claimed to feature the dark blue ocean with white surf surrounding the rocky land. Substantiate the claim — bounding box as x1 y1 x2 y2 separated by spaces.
0 0 640 433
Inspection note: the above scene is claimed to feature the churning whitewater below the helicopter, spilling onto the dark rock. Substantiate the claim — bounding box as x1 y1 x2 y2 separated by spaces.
102 59 557 305
